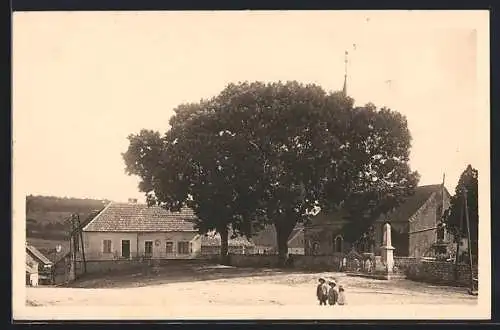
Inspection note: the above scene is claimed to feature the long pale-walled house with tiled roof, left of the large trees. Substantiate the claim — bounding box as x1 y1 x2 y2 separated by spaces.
77 202 201 261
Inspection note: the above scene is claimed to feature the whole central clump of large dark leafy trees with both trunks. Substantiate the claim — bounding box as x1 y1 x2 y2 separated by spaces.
123 82 418 258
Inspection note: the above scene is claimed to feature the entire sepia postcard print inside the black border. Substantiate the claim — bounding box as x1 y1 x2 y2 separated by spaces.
12 10 491 320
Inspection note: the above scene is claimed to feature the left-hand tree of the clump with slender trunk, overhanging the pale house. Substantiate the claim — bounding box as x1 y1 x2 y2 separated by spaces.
123 99 264 258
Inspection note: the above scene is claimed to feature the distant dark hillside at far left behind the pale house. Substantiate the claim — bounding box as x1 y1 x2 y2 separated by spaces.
26 195 109 253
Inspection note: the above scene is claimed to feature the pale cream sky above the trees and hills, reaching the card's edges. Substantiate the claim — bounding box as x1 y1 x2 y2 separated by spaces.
12 11 489 201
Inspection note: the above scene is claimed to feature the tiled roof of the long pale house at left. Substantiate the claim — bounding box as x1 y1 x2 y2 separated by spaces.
83 202 196 232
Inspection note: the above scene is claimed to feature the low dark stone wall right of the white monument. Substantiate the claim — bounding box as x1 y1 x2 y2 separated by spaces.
406 260 477 286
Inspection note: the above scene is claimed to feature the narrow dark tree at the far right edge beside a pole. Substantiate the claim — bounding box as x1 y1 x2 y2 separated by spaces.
444 165 479 255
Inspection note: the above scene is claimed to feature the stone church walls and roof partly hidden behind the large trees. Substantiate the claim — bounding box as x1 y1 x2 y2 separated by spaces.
304 185 451 257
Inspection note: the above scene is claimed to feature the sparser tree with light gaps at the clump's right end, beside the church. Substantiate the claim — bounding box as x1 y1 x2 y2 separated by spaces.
332 104 420 245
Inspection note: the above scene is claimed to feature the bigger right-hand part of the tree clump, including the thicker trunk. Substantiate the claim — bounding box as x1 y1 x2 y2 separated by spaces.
211 82 418 261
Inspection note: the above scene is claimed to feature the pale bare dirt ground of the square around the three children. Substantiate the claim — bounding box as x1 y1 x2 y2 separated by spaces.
26 266 477 306
